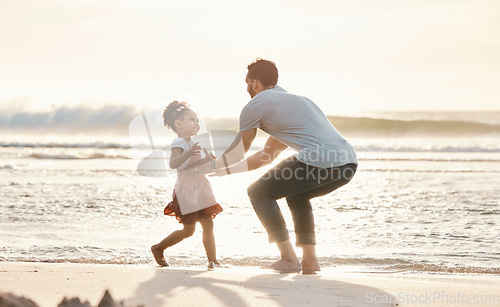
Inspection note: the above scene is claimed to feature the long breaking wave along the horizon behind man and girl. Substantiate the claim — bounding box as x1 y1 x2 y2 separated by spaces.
0 104 500 137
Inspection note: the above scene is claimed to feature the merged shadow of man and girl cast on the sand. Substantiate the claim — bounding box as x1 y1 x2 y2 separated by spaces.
125 268 397 307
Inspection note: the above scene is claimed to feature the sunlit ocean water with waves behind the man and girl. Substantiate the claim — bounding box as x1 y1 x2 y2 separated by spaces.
0 112 500 274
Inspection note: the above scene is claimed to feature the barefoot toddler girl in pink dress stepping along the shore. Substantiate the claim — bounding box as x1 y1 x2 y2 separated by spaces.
151 101 222 268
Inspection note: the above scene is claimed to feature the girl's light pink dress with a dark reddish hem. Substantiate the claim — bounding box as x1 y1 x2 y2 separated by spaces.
163 139 222 224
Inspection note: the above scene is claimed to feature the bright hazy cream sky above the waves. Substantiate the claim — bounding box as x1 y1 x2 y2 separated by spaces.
0 0 500 116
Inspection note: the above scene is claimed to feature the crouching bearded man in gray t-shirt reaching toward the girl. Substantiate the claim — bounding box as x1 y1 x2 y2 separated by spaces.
199 59 358 274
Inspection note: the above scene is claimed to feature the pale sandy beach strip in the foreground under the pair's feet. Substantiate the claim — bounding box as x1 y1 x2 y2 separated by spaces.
0 262 500 307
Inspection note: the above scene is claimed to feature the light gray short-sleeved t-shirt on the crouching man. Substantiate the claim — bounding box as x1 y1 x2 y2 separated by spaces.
240 86 358 168
